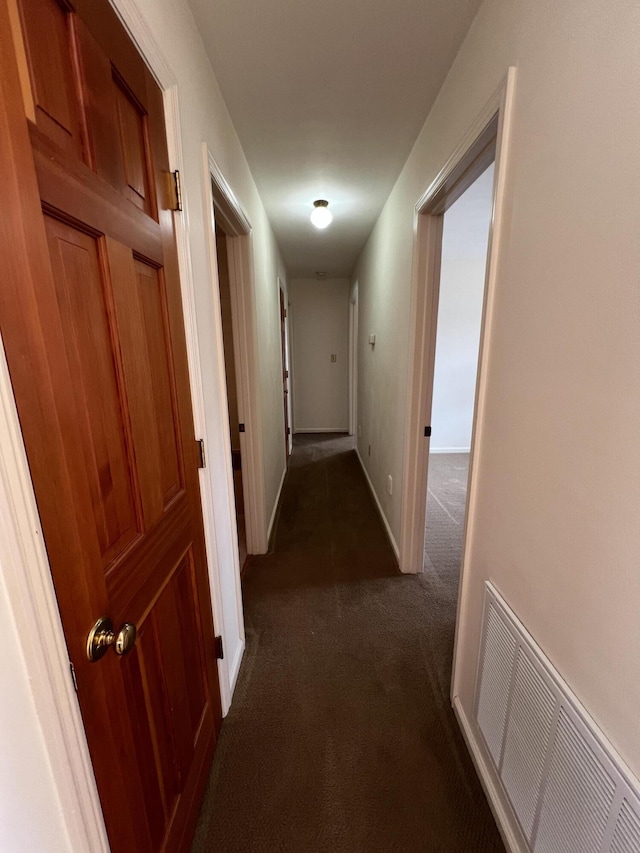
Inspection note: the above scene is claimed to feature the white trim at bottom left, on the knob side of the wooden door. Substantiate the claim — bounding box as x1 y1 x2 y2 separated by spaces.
0 336 109 853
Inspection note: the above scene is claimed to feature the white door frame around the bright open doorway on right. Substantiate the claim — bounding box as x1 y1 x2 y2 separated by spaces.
399 68 516 584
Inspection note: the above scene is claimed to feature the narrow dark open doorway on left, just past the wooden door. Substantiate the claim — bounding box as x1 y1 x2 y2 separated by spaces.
215 219 247 571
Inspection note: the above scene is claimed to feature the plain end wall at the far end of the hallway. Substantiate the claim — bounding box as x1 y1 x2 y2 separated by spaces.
289 278 350 432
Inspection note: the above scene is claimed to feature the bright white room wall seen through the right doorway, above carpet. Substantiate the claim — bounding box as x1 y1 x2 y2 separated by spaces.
429 164 493 453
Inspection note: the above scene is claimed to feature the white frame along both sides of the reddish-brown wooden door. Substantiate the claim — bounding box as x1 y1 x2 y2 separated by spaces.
0 0 248 853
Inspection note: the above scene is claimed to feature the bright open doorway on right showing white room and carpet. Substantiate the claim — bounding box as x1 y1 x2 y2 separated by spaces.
424 163 494 576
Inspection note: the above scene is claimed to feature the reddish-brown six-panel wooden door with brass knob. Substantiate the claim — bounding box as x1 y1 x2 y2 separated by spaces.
0 0 221 853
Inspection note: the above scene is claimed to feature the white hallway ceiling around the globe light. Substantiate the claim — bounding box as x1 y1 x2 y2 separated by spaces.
189 0 481 278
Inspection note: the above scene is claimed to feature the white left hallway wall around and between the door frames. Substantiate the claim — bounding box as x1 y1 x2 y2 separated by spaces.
0 0 286 853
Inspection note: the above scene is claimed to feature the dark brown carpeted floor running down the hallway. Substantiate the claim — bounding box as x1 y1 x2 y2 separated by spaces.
192 436 504 853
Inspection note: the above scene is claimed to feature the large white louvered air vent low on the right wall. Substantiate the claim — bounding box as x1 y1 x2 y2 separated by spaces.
476 583 640 853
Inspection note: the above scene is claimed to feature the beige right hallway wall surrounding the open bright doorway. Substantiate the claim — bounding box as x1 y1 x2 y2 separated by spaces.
356 0 640 775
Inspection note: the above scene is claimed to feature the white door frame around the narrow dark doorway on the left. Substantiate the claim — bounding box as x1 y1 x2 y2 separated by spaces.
202 142 269 552
